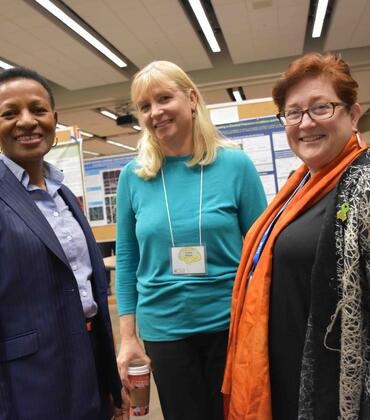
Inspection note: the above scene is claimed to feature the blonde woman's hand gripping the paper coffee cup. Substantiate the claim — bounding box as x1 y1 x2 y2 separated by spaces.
117 335 151 389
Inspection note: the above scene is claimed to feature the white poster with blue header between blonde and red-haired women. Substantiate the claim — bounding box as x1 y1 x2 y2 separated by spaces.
217 115 302 202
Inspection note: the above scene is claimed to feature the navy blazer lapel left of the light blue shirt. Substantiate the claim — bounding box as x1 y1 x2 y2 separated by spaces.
0 161 69 266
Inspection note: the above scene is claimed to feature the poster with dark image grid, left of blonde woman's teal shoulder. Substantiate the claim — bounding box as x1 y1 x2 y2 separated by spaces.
84 154 135 226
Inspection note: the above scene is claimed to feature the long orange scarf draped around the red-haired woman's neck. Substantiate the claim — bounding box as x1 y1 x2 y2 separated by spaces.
222 135 367 420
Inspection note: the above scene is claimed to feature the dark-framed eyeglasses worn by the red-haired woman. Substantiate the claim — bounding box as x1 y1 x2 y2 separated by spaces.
276 102 346 127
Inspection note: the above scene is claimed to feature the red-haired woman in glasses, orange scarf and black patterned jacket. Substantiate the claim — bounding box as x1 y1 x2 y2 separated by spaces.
223 53 370 420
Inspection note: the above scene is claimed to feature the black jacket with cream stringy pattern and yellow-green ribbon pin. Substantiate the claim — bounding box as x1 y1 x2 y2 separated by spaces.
298 149 370 420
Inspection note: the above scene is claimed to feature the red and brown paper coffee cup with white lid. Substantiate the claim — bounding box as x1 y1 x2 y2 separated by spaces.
127 364 150 416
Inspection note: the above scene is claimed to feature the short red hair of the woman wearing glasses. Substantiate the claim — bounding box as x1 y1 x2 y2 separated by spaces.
272 53 358 112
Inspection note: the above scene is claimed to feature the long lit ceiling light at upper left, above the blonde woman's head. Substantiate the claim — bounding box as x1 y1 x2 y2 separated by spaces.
34 0 127 67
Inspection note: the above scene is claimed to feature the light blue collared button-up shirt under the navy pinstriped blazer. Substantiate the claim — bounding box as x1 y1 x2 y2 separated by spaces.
1 155 98 318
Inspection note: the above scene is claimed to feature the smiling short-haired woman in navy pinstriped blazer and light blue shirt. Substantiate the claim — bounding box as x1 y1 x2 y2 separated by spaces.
0 68 128 420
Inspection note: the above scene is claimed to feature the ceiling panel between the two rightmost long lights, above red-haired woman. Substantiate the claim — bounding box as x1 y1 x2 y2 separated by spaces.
212 0 309 63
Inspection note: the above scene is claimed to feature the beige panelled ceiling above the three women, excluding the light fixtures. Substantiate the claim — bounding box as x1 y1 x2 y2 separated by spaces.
0 0 370 158
